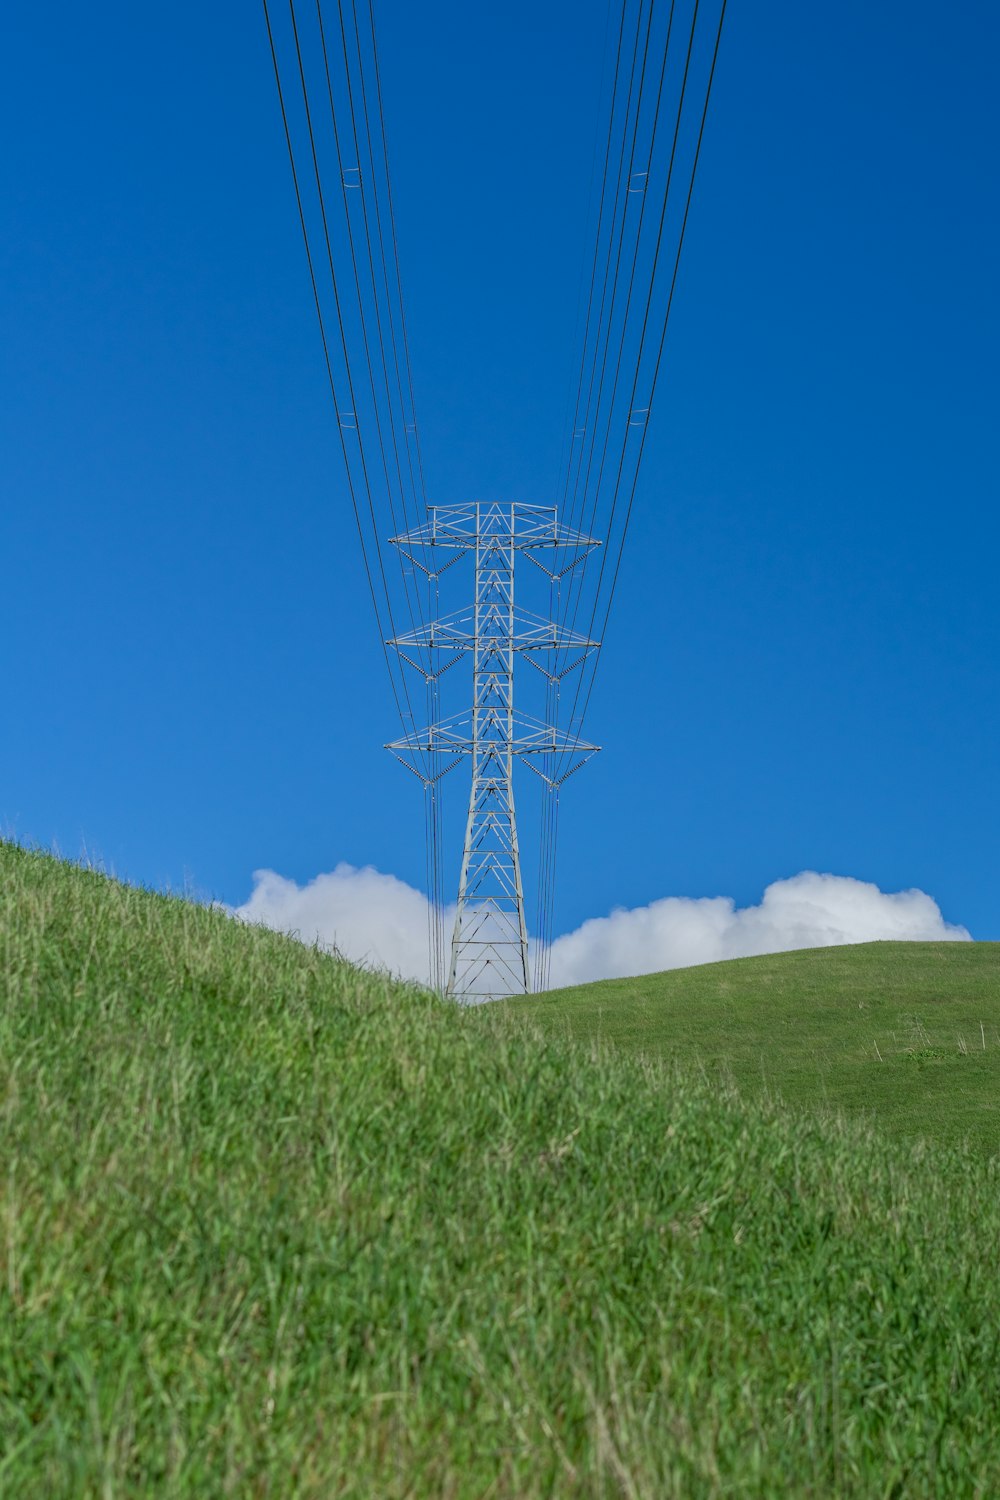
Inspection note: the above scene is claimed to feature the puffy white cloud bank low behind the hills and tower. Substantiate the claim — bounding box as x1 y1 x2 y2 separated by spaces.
229 864 970 989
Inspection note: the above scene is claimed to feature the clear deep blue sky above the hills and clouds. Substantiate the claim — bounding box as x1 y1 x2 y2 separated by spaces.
0 0 1000 938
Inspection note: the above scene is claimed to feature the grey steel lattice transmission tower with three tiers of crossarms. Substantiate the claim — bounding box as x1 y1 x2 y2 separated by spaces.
387 503 598 1001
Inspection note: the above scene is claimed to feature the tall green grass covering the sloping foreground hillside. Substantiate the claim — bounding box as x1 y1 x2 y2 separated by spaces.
0 846 1000 1500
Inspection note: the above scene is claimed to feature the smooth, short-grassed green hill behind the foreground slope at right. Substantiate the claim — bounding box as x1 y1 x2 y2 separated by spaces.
513 942 1000 1157
